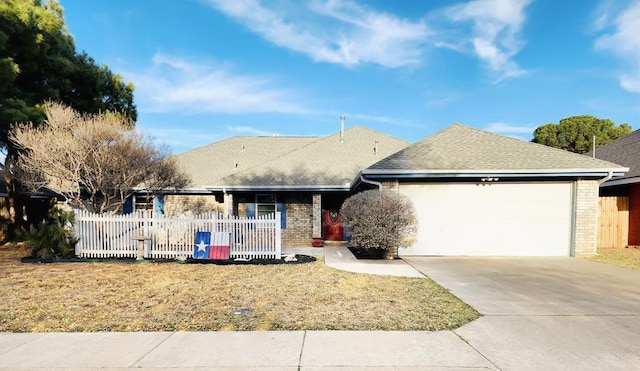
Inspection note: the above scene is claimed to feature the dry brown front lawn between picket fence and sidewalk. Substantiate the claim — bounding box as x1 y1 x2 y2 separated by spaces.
0 247 479 332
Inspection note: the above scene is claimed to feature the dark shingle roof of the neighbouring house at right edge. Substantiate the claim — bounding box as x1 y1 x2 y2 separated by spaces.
596 130 640 179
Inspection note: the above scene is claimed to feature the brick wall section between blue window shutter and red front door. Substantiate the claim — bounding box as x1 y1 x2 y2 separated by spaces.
282 194 313 246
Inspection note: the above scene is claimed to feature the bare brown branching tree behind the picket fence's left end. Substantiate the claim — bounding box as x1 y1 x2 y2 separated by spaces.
10 102 189 214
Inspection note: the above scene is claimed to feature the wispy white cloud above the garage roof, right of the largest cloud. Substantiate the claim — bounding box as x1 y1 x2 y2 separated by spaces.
436 0 531 82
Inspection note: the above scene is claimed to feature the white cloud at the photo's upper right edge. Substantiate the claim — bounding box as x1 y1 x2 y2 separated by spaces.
594 0 640 93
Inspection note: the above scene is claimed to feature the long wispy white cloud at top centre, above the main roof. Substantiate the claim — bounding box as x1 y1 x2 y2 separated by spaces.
206 0 428 68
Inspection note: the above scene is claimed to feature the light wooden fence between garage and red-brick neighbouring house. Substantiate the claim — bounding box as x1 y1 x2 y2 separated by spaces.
598 196 629 247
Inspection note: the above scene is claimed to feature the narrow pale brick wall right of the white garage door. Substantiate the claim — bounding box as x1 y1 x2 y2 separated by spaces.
574 180 599 257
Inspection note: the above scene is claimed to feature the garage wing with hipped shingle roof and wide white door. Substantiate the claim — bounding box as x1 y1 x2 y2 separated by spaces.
362 124 628 256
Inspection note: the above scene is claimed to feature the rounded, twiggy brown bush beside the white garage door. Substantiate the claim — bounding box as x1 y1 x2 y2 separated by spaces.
340 190 418 257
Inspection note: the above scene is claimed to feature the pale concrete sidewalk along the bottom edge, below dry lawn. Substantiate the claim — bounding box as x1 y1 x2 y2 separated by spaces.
0 331 496 370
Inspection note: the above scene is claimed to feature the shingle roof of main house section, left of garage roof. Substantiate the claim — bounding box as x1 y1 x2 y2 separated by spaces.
175 126 409 189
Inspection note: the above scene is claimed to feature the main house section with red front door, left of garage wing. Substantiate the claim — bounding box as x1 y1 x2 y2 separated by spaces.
162 127 409 246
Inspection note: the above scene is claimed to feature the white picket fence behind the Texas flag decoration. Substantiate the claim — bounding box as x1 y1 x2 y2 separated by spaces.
75 210 282 259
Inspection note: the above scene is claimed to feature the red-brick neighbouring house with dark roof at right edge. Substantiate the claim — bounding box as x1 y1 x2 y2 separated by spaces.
588 130 640 245
